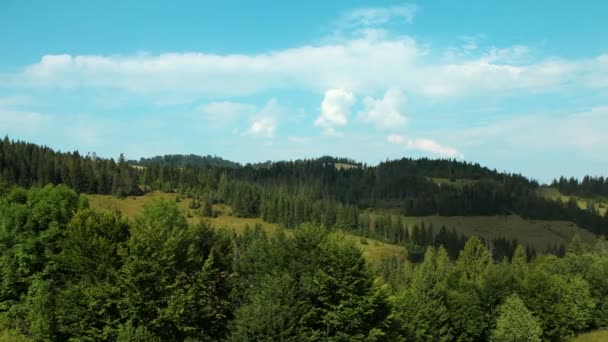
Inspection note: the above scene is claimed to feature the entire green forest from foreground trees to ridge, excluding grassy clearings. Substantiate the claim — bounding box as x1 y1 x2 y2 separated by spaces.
0 138 608 341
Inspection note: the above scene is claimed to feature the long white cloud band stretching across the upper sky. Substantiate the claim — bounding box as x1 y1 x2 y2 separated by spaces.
15 36 608 98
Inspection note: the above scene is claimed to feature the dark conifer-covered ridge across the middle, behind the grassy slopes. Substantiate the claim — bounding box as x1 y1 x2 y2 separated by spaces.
0 138 608 238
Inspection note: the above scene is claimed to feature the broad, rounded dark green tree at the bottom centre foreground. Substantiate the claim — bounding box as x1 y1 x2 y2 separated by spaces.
231 227 389 341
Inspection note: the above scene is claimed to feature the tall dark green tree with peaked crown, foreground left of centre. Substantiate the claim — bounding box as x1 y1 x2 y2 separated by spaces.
119 201 230 340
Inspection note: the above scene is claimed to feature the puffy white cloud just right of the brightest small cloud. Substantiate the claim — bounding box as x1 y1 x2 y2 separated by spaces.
359 89 407 129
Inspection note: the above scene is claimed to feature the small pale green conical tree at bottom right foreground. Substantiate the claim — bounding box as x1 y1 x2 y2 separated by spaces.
492 294 543 342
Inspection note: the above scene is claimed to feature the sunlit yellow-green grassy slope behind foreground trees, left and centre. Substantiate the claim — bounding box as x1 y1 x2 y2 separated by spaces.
88 192 407 262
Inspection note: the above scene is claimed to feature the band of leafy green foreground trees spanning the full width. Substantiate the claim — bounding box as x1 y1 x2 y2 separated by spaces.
0 186 608 341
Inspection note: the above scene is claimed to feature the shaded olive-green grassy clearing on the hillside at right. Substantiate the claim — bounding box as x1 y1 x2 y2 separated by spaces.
370 210 595 250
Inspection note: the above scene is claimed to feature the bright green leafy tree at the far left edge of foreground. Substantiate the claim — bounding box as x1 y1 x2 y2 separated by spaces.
0 186 79 339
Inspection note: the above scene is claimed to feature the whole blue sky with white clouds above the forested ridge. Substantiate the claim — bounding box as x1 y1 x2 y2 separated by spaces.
0 0 608 181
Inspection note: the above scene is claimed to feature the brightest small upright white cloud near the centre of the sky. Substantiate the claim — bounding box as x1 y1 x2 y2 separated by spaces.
315 89 355 135
